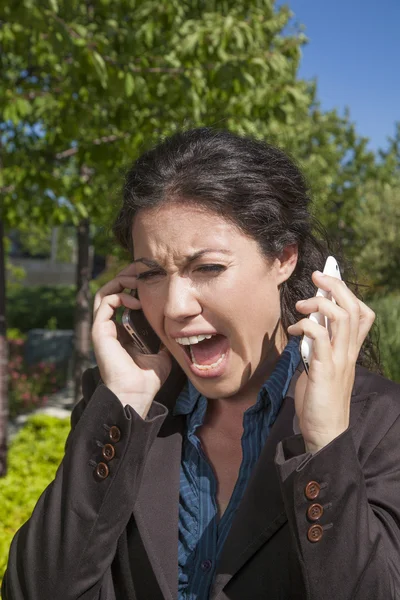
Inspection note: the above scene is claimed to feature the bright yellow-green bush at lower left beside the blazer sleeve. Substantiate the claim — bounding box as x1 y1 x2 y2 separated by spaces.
0 415 70 581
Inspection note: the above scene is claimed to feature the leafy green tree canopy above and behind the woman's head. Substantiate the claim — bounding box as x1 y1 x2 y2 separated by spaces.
0 0 390 247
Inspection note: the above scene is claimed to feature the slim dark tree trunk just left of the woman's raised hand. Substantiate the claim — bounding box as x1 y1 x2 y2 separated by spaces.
74 219 92 403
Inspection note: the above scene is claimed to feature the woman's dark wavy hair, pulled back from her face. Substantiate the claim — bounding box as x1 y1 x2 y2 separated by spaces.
113 128 378 366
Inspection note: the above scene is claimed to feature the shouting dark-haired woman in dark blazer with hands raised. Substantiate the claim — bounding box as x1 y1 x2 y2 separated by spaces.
3 129 400 600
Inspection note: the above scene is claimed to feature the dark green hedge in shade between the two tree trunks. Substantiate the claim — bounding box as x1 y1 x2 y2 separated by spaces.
7 285 76 332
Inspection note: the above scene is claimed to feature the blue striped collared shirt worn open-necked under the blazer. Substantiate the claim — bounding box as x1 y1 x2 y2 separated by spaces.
174 338 300 600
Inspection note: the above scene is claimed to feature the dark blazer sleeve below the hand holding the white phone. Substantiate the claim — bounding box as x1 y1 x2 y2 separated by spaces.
276 386 400 600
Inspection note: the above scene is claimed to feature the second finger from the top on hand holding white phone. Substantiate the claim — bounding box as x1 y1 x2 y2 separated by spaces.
296 296 350 358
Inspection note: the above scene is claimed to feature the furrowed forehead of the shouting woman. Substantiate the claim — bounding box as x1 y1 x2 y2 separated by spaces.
132 203 256 258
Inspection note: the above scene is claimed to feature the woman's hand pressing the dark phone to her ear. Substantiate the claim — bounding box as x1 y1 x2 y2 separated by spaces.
92 265 172 418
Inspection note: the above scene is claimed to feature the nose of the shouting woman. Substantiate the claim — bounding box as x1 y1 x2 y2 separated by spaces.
164 276 202 322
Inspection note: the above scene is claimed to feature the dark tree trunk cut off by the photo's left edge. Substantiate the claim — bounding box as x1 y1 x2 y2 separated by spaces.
0 219 8 477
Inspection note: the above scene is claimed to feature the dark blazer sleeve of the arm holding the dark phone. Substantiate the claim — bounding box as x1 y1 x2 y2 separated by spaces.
2 370 168 600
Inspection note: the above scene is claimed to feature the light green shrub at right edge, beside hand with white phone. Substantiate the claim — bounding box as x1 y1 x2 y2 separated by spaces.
367 294 400 382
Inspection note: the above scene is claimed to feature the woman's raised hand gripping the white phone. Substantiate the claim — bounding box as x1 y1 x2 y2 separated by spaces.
288 271 375 453
